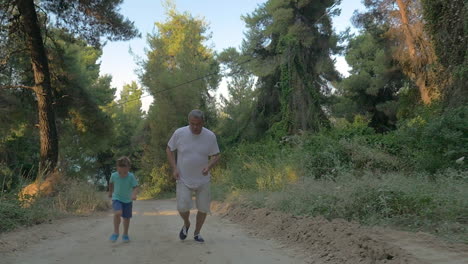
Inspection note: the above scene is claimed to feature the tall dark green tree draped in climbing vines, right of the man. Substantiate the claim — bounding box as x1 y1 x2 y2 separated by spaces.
243 0 338 137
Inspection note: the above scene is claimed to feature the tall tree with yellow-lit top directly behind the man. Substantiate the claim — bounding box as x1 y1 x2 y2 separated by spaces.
141 4 219 175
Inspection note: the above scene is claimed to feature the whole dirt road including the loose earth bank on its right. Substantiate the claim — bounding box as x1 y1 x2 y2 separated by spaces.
0 200 468 264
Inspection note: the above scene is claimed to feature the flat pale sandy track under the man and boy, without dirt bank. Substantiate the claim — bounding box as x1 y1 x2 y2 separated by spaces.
0 200 308 264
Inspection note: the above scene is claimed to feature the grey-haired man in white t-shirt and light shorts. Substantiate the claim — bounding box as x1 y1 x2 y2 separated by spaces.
166 110 219 242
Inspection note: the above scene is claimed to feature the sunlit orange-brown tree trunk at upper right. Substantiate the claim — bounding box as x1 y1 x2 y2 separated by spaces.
396 0 431 104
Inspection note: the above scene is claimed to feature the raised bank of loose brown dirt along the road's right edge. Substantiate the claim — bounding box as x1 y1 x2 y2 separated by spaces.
215 205 421 264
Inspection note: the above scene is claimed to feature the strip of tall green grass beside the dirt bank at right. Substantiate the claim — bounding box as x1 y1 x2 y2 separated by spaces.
214 171 468 243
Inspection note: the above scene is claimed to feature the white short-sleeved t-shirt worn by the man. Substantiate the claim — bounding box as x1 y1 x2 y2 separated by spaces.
167 126 219 188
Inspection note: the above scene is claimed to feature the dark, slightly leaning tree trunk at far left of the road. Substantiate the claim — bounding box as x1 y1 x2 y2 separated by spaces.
16 0 58 175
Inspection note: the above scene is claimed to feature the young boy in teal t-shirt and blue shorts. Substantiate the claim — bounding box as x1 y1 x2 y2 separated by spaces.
109 157 138 242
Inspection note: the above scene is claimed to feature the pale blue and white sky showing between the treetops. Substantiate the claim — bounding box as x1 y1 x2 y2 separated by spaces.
100 0 364 111
